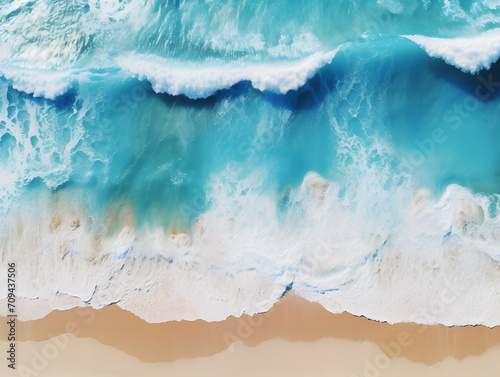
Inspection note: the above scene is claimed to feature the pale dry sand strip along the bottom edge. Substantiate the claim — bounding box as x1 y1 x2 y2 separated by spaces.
0 335 500 377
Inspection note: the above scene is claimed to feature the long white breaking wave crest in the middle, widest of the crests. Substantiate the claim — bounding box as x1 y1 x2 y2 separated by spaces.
118 48 339 99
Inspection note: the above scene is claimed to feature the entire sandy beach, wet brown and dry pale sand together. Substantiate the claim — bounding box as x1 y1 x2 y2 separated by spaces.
2 295 500 376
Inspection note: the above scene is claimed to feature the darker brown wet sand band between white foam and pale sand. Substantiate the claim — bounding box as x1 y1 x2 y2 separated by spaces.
2 295 500 369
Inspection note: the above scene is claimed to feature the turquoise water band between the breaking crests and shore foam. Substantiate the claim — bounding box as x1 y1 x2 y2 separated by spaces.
0 38 500 227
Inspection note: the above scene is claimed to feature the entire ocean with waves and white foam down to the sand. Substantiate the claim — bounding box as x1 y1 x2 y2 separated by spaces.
0 0 500 326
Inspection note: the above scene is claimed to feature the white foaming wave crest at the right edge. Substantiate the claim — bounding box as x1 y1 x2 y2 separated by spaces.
403 29 500 73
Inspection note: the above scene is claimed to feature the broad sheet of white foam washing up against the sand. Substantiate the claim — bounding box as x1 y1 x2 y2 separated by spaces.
0 168 500 326
